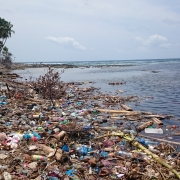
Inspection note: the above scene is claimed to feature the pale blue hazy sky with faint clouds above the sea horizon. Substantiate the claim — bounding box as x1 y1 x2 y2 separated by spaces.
0 0 180 62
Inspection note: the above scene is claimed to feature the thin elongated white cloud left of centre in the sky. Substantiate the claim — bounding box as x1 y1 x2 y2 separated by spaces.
46 36 86 50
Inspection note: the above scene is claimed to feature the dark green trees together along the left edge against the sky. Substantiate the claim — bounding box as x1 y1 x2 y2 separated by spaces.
0 17 15 69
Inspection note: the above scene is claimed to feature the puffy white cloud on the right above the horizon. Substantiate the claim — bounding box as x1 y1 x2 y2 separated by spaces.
135 34 171 48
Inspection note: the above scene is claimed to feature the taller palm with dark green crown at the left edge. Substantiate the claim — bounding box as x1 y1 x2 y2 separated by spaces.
0 18 14 53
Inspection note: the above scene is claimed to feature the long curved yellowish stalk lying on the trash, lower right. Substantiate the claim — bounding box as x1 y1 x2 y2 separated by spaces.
94 131 180 179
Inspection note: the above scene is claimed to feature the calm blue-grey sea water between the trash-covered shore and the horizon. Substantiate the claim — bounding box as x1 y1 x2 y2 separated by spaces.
13 59 180 120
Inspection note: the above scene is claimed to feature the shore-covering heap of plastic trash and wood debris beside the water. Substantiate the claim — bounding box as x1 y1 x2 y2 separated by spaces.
0 69 180 180
